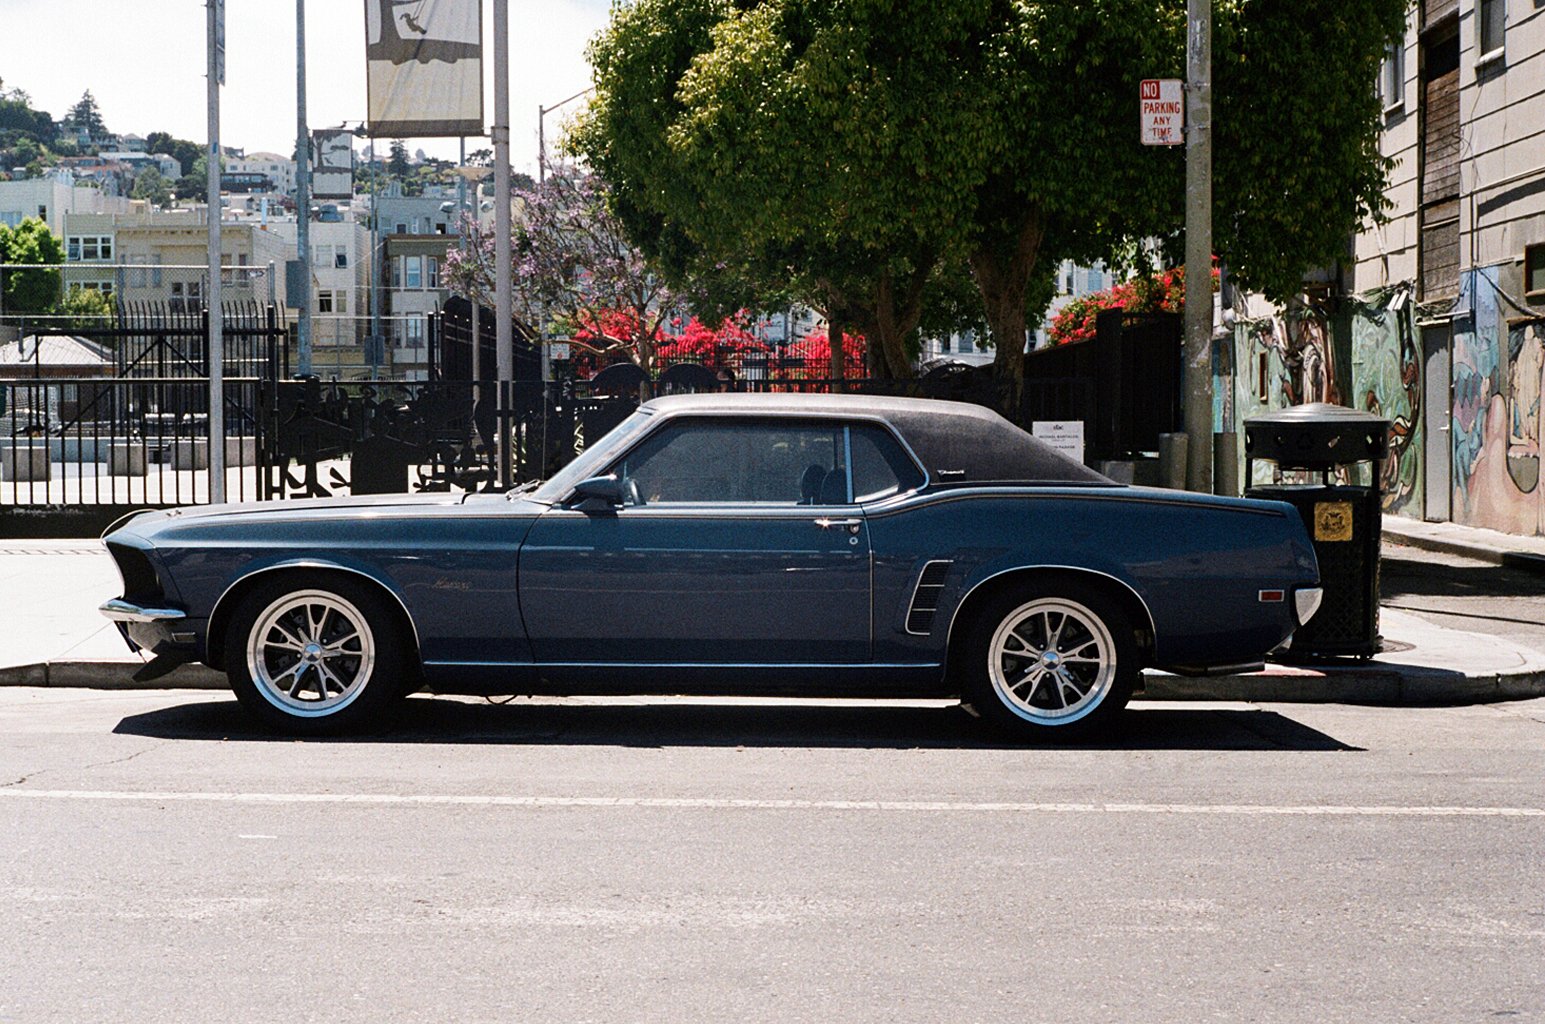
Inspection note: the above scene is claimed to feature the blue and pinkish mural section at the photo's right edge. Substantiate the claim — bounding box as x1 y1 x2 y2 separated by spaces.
1454 267 1545 536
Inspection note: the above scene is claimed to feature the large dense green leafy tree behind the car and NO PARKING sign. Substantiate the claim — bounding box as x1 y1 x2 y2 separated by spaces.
575 0 1406 389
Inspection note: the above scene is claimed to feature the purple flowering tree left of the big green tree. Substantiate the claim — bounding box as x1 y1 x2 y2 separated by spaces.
445 164 686 374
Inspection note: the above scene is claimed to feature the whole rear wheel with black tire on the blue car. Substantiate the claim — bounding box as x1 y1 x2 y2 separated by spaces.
952 579 1142 743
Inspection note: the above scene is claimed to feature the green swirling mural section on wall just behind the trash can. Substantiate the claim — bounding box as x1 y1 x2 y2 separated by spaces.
1349 295 1426 519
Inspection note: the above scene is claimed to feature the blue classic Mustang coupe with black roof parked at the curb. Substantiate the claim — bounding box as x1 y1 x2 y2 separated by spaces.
102 395 1321 738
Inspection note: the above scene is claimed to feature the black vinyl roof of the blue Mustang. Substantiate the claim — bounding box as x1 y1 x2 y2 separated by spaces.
644 392 1115 487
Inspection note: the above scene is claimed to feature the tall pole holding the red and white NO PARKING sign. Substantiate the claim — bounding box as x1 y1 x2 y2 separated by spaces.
1185 0 1213 494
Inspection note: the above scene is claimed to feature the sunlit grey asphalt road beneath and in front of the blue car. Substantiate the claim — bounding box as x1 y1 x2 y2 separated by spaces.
0 689 1545 1024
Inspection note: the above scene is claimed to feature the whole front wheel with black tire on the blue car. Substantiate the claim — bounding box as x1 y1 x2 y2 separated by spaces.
226 571 417 735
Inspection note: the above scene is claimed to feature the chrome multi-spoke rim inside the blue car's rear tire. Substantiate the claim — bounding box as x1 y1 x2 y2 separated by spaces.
987 598 1117 724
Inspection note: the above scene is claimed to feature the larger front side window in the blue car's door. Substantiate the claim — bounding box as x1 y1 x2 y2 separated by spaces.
615 420 848 505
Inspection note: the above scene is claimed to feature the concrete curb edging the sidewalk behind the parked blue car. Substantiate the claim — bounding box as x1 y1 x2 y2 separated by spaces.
9 661 1545 704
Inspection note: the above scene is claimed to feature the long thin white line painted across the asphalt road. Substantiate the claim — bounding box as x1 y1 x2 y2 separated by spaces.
0 788 1545 817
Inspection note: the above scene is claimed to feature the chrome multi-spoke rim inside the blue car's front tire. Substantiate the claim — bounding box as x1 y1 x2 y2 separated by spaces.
247 590 375 718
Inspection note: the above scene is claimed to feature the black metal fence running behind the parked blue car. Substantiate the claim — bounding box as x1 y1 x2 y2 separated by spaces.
0 307 1180 536
